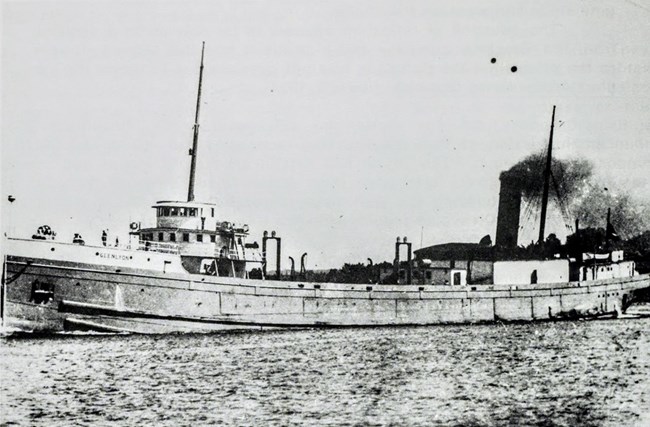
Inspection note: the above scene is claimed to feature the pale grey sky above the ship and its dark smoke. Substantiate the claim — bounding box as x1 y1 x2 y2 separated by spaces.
0 0 650 268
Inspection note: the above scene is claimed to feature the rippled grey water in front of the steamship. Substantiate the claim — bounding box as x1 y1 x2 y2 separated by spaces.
0 319 650 426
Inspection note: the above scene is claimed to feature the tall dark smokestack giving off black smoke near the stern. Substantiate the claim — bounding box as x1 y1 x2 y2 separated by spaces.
495 172 521 248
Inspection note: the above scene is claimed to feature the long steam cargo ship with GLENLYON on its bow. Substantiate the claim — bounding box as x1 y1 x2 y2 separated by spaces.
0 44 650 334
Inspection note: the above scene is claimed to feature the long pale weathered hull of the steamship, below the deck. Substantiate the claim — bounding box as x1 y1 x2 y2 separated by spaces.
3 252 650 333
